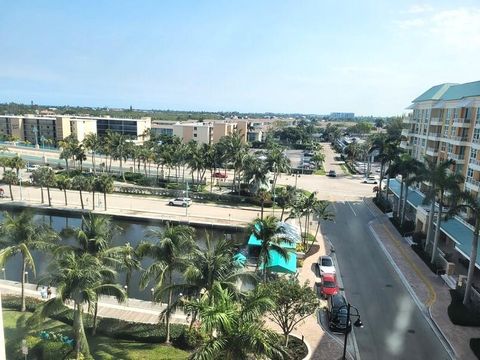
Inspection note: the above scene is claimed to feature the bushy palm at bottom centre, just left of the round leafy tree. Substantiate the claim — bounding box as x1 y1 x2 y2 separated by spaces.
184 283 286 360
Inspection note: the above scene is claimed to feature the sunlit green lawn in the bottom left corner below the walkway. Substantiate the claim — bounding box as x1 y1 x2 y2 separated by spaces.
3 310 188 360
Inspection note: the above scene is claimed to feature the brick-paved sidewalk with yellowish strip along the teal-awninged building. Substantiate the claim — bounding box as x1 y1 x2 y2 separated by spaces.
365 199 480 360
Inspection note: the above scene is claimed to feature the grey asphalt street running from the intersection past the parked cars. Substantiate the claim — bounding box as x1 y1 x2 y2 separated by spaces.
322 201 450 360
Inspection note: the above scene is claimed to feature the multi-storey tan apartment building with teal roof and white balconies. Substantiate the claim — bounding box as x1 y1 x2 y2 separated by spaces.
400 81 480 194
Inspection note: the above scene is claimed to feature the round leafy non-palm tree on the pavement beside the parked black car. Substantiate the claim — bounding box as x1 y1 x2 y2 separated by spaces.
260 278 320 346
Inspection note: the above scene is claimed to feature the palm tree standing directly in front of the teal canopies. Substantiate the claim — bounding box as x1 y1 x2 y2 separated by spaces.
248 215 293 281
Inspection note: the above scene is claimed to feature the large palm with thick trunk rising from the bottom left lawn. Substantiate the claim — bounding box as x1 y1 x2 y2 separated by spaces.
34 250 126 359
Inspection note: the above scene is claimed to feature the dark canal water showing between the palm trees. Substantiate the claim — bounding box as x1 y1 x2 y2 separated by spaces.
0 213 246 300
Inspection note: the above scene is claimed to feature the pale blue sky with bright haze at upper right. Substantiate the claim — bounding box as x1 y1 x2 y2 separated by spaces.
0 0 480 116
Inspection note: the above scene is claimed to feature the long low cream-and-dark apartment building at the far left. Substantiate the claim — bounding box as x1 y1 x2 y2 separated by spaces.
0 114 151 145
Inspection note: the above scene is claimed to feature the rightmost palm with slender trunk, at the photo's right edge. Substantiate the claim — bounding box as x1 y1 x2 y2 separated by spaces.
447 191 480 305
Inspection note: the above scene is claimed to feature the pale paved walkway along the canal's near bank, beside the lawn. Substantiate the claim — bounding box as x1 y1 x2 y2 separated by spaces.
0 280 188 324
